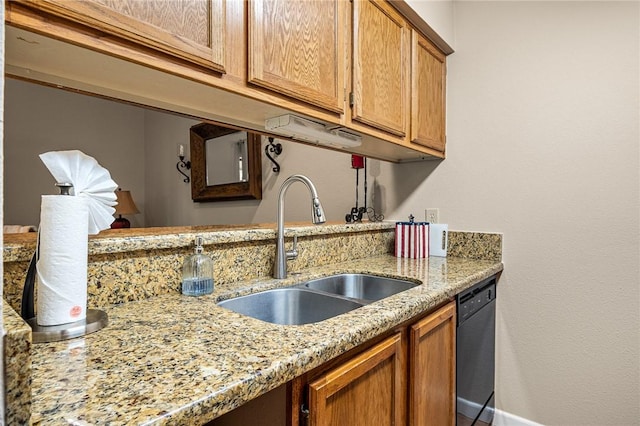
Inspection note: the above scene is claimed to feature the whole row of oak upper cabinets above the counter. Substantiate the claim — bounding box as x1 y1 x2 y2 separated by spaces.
5 0 448 162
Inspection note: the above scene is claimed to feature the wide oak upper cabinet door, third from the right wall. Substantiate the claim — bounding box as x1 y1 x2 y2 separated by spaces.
248 0 345 113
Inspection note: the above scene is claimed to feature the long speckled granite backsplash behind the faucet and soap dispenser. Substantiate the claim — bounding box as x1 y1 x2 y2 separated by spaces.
4 222 393 311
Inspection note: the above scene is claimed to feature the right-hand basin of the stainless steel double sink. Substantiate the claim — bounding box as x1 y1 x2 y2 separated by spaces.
304 274 418 302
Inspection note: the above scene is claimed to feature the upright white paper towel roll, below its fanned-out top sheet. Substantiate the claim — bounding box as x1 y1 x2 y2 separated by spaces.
36 195 89 326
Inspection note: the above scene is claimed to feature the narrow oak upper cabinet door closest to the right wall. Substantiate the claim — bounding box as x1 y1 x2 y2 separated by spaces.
411 30 446 152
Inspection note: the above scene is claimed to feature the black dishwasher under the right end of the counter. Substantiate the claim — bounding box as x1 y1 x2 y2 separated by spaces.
456 277 496 426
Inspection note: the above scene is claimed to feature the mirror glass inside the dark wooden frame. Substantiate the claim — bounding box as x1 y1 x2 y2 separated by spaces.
205 131 249 186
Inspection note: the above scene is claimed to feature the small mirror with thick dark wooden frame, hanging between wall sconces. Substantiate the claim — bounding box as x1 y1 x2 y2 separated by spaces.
189 123 262 202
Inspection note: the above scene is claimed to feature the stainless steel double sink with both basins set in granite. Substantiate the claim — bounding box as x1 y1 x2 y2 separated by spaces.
218 274 418 325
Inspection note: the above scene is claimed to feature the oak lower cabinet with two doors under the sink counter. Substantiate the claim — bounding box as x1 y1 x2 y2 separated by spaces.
289 302 456 426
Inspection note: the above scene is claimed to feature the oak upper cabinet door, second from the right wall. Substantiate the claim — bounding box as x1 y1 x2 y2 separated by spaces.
352 0 409 136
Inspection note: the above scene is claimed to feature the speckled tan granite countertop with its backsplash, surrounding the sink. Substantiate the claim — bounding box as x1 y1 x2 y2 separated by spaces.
4 223 502 425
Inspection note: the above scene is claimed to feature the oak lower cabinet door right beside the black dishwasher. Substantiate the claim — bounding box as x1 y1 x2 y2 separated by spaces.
409 302 456 426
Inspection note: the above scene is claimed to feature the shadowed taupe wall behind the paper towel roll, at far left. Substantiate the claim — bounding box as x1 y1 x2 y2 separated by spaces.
4 79 145 226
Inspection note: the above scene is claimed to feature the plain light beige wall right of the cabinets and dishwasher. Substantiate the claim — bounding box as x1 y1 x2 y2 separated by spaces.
381 1 640 426
